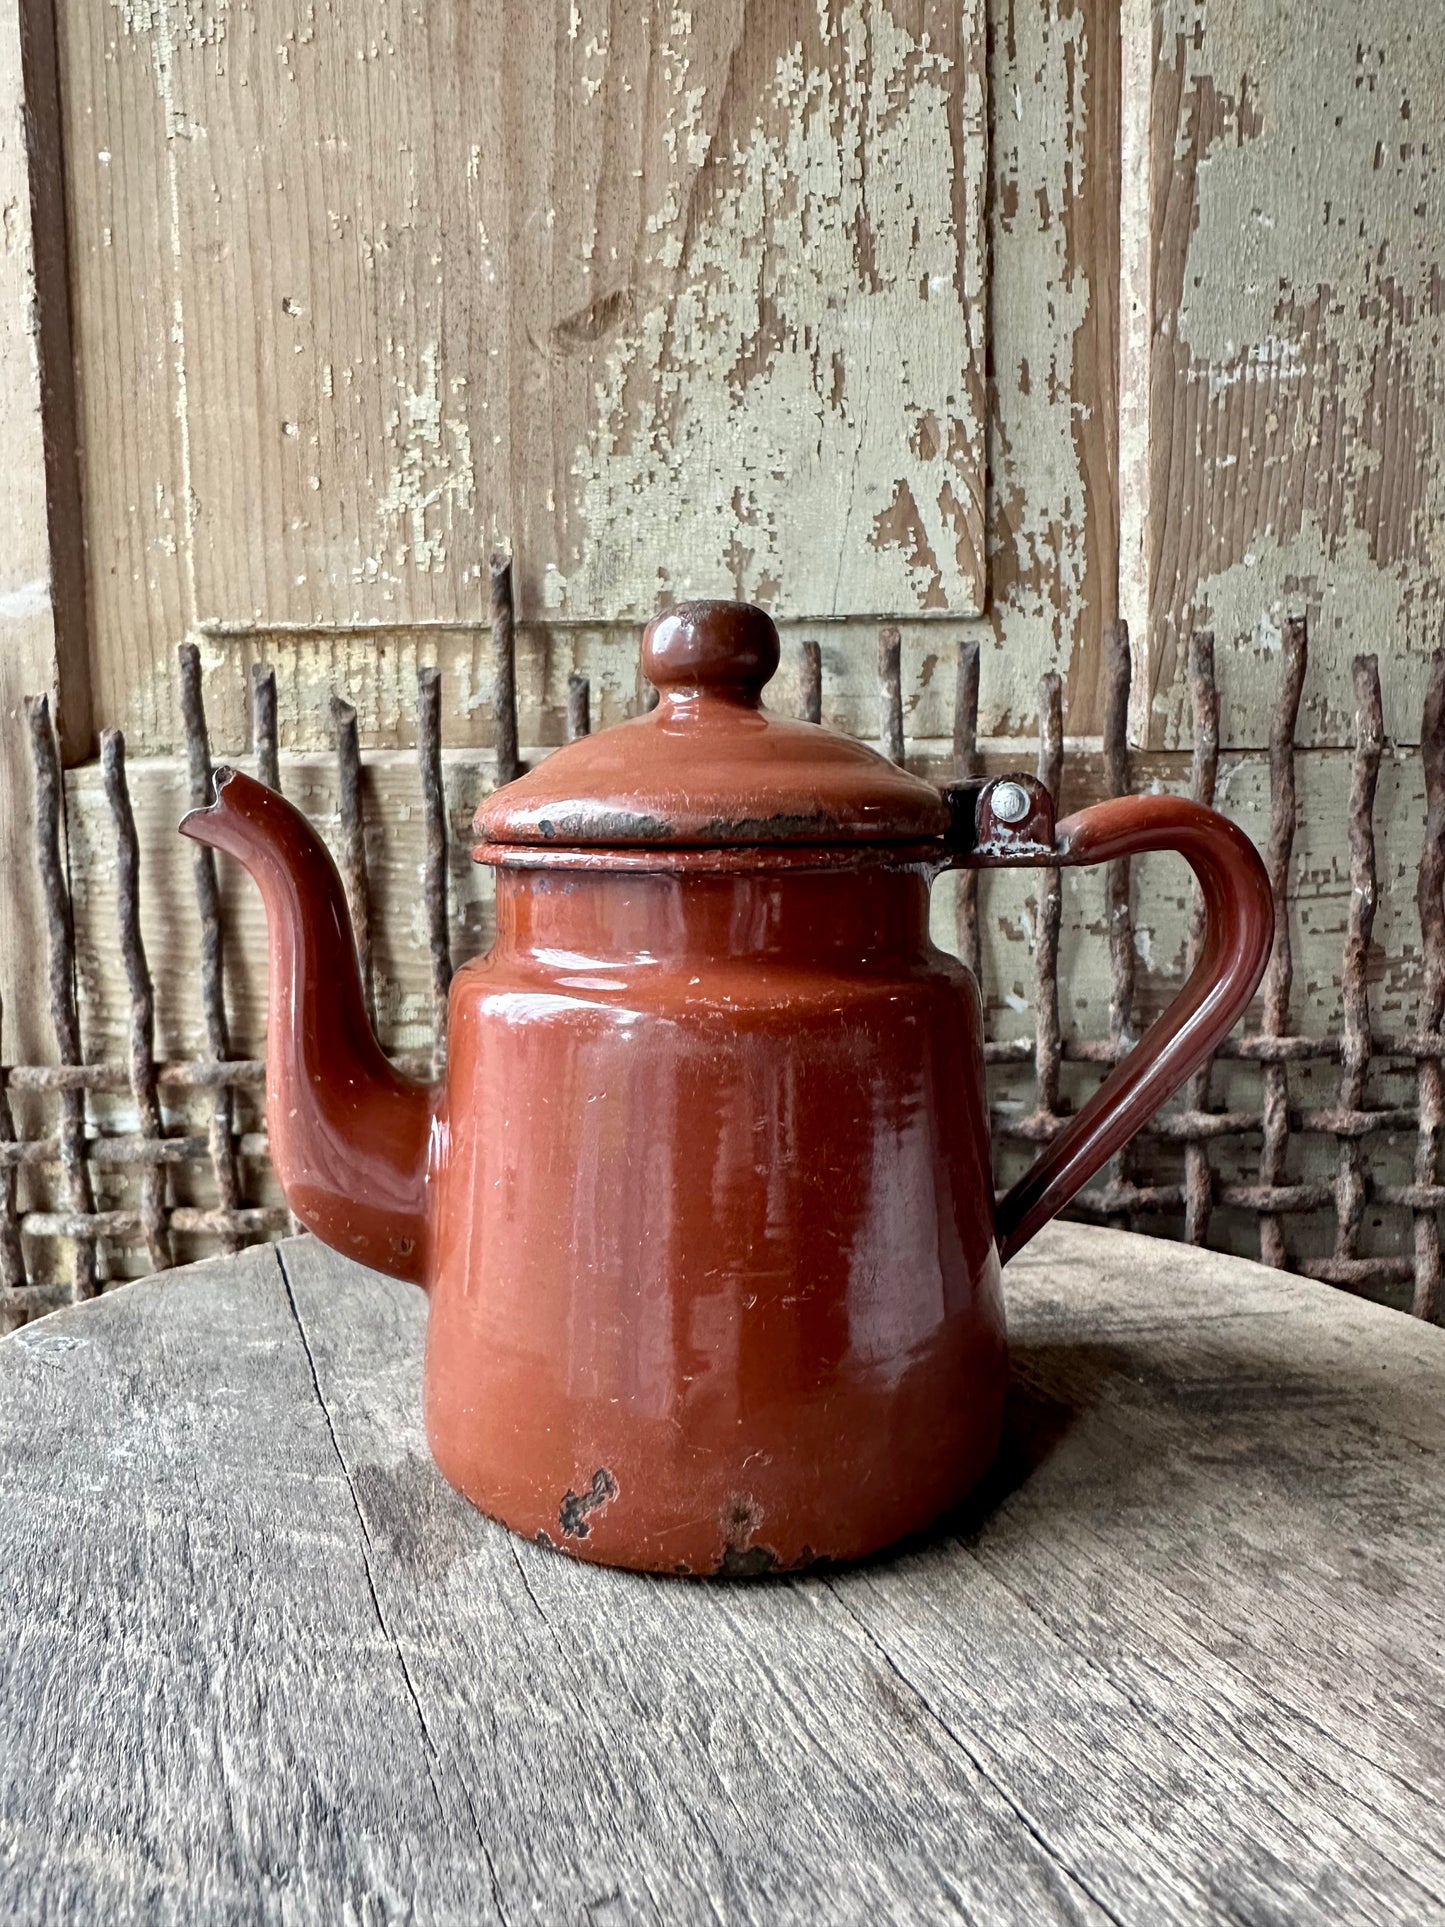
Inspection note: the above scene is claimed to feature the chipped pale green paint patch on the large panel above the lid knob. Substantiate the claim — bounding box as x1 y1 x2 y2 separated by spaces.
558 0 985 619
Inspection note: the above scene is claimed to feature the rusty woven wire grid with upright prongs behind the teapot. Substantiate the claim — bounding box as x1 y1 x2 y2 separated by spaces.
0 585 1445 1328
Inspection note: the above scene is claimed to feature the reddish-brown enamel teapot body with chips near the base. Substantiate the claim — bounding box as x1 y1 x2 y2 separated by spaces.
426 850 1006 1572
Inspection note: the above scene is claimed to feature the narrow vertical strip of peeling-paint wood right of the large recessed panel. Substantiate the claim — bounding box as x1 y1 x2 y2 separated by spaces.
981 0 1119 736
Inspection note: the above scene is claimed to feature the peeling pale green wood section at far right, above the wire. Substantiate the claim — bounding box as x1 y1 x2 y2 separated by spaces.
1121 0 1445 746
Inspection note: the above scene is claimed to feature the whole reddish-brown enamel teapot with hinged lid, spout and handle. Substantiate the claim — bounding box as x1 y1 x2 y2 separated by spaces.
181 603 1274 1572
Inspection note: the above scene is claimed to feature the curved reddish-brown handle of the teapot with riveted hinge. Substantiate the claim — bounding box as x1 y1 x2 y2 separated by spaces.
944 777 1274 1264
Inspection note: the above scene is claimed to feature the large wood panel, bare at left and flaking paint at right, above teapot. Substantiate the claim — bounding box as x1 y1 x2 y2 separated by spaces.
60 0 986 746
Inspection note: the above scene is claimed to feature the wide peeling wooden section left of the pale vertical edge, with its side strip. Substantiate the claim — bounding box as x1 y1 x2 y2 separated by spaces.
39 0 1117 753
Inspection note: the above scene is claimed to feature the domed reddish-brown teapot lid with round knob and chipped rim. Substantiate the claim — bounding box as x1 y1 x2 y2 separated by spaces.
472 601 948 848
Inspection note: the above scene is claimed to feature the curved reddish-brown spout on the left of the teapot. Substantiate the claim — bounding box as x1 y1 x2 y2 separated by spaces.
181 767 437 1283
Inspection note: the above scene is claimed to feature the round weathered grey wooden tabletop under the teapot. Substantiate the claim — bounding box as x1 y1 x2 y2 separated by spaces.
0 1227 1445 1927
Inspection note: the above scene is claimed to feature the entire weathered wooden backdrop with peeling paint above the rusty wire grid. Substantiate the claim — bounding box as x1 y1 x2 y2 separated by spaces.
33 0 1445 753
